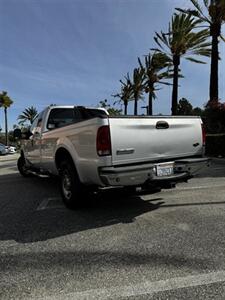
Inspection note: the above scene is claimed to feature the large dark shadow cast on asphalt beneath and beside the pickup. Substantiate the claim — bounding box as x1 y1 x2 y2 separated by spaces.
0 174 164 243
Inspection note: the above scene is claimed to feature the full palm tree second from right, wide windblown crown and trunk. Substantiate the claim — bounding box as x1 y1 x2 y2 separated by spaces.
154 13 211 115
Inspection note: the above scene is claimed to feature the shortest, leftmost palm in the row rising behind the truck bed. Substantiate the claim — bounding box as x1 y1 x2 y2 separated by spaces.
112 74 134 116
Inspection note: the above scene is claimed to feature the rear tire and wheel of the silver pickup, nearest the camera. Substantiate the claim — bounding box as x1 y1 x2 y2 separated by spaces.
60 159 87 210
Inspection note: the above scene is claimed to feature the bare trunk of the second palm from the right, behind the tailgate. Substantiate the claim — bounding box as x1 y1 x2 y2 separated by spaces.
171 55 180 116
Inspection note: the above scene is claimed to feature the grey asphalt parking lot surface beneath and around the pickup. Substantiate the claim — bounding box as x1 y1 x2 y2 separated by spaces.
0 155 225 300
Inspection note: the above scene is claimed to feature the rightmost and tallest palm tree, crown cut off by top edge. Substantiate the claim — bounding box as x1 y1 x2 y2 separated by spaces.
177 0 225 102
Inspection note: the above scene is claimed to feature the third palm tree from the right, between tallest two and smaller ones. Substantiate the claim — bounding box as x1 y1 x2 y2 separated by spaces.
138 52 172 115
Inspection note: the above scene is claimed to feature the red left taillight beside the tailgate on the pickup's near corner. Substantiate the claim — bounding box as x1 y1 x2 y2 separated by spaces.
96 126 112 156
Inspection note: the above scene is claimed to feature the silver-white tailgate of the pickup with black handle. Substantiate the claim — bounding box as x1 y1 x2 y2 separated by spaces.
109 117 202 165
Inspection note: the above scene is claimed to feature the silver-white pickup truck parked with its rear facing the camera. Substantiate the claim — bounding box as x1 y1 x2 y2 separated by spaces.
15 105 208 208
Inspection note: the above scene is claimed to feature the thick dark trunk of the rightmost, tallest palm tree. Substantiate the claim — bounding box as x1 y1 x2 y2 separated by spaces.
209 23 221 101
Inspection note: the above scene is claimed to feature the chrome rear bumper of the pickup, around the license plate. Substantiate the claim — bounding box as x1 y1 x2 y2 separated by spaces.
99 158 210 186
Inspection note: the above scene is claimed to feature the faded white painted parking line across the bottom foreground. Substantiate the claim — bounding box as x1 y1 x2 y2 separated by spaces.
40 271 225 300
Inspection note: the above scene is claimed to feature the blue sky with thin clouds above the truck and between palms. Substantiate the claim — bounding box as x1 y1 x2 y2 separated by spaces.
0 0 225 131
